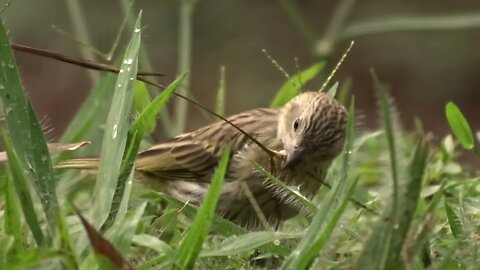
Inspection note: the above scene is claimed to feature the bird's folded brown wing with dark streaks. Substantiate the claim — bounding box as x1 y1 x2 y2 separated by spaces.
136 109 277 181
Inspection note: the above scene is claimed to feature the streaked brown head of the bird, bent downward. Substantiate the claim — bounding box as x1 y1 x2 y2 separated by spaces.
278 92 347 168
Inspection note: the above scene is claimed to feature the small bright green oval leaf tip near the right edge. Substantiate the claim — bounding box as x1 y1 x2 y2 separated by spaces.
445 102 475 149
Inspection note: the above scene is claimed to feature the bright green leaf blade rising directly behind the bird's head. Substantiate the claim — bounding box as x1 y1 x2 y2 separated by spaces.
270 62 325 107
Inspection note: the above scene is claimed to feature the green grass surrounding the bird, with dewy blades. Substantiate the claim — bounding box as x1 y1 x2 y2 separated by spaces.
0 9 480 269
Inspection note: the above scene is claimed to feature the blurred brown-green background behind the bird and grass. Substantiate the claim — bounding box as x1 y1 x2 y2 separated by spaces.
2 0 480 146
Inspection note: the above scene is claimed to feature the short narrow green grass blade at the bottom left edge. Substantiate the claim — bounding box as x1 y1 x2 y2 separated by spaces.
1 174 26 256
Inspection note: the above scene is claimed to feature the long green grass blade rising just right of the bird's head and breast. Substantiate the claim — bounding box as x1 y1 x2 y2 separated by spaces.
282 99 357 269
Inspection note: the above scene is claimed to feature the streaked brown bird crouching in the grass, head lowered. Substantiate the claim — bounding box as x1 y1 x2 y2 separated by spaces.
61 92 347 225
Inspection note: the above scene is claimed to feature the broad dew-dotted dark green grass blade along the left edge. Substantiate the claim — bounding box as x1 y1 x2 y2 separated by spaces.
0 20 58 237
